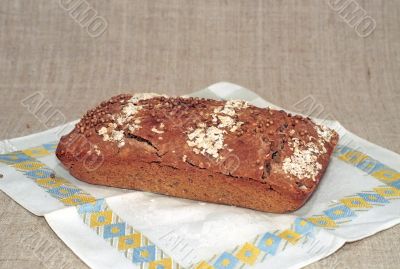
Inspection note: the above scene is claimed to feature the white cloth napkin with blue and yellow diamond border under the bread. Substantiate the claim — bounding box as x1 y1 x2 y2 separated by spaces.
0 82 400 269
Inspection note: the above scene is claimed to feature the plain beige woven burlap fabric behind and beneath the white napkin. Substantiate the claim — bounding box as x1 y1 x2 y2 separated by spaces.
0 0 400 268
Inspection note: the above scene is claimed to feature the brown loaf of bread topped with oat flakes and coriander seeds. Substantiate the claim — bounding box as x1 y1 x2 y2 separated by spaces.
56 93 338 213
